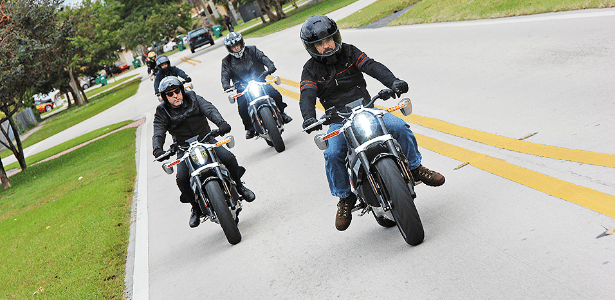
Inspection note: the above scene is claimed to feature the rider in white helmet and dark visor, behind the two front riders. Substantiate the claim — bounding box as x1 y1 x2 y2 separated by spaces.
222 32 293 139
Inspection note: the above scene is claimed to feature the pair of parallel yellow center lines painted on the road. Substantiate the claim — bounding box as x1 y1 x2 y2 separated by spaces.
275 79 615 218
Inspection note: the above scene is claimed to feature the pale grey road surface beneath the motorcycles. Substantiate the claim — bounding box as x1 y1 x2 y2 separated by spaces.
9 1 615 299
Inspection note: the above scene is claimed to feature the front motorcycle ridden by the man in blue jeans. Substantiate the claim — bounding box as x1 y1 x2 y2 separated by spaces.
304 89 425 246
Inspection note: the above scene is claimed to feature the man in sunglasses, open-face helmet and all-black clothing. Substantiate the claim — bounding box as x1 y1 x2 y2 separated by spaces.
152 76 256 228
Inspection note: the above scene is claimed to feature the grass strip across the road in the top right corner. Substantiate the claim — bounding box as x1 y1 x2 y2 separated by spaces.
392 0 615 25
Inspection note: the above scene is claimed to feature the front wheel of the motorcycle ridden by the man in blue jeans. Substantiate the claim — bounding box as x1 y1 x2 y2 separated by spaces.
376 157 425 246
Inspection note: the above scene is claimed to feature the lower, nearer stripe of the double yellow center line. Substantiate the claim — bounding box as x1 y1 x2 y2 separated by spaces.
275 76 615 218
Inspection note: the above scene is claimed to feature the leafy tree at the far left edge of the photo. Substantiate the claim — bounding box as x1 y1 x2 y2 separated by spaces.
0 0 71 187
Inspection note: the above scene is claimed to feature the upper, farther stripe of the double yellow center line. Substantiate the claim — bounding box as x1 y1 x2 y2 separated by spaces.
282 79 615 168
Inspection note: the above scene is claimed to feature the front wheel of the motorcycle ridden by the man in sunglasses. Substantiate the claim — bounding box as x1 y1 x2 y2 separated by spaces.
205 180 241 245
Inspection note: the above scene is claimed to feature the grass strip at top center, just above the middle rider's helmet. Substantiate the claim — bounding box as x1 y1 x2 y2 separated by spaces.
241 0 357 37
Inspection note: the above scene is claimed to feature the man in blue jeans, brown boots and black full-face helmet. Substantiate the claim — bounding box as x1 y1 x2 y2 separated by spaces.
299 15 444 231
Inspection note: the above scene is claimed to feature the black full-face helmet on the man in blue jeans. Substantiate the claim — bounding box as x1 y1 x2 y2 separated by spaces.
300 15 342 63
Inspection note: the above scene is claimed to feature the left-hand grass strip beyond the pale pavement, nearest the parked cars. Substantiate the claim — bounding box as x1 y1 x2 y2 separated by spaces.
0 77 141 162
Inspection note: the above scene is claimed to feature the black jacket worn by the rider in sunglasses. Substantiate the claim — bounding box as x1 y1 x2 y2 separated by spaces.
152 91 225 152
